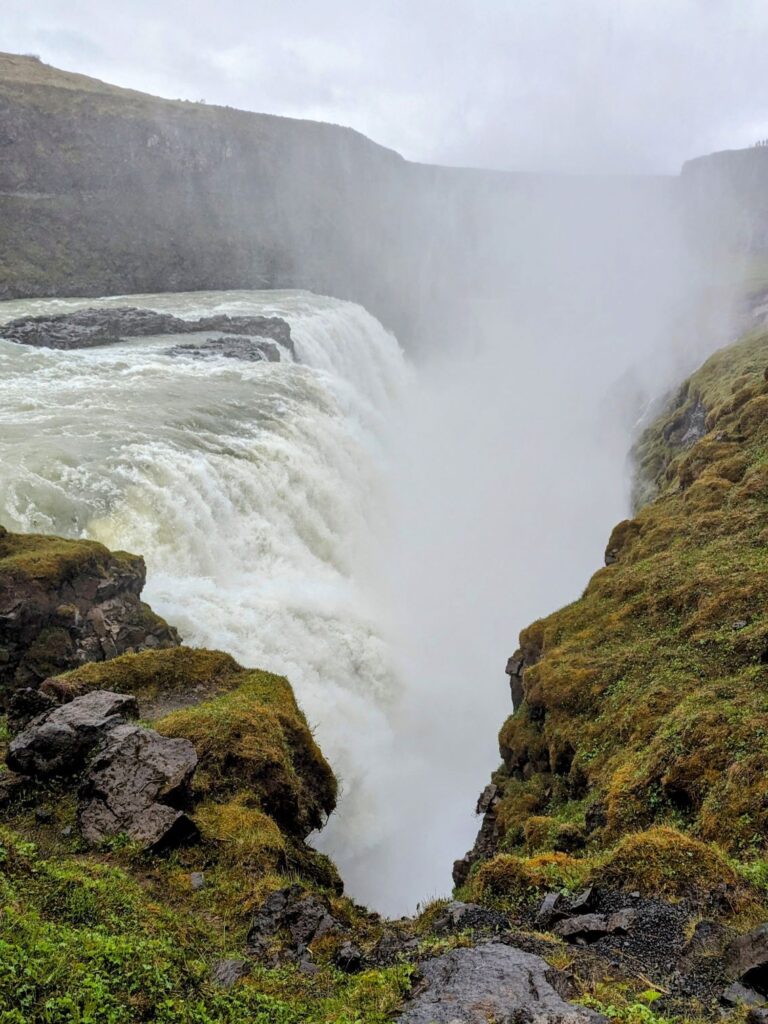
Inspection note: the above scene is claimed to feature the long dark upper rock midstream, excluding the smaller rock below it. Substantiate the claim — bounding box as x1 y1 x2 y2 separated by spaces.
1 307 294 354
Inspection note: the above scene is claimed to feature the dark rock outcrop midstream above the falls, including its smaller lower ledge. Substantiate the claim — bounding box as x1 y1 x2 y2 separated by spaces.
0 307 295 361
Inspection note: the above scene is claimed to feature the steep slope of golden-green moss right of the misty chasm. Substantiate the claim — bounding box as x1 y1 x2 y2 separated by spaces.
470 321 768 910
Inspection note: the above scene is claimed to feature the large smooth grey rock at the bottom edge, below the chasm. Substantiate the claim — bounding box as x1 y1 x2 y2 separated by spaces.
397 943 604 1024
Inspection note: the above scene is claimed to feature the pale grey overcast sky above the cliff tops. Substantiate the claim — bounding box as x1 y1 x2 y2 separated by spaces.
0 0 768 172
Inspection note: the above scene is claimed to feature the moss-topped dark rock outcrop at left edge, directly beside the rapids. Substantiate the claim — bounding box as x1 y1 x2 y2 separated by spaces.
0 526 179 699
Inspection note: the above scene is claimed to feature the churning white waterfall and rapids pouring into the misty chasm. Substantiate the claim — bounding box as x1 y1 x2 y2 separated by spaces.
0 292 434 913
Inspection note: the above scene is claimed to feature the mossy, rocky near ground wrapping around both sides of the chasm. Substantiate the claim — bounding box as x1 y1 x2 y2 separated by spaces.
0 314 768 1024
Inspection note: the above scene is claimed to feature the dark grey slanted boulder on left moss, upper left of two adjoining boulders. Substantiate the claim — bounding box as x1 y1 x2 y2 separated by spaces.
6 690 138 778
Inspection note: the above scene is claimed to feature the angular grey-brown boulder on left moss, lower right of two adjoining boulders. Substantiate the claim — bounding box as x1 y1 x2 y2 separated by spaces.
77 724 198 850
